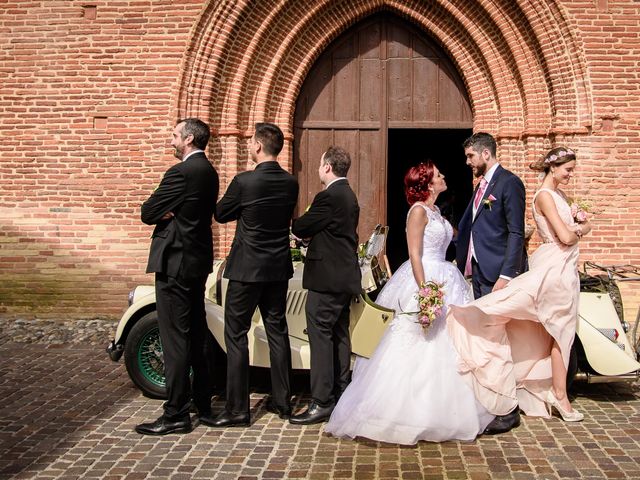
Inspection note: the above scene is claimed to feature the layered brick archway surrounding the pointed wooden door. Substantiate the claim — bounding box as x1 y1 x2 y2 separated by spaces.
176 0 593 245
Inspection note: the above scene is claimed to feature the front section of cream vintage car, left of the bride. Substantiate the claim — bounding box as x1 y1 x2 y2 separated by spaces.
107 226 394 398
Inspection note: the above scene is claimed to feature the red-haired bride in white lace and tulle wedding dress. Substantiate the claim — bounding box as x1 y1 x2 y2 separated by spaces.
325 161 494 445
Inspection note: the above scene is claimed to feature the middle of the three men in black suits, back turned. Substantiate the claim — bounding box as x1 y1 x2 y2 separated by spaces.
210 123 298 427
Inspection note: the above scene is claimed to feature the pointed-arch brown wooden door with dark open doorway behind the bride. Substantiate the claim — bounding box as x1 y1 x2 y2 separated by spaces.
293 12 473 267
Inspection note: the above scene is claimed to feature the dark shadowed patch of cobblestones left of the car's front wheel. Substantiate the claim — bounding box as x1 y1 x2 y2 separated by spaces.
0 343 140 478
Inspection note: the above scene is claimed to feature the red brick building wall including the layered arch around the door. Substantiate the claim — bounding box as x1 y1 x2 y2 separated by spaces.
0 0 640 318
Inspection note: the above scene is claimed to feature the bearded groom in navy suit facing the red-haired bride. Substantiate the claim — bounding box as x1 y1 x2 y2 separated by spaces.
456 132 526 298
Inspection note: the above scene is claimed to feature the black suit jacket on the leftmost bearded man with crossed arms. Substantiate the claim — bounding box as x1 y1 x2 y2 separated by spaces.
141 152 219 279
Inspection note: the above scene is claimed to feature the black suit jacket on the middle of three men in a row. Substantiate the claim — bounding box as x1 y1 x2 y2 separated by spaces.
215 161 298 282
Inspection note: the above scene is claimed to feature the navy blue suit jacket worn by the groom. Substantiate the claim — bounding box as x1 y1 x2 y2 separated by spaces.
456 165 526 283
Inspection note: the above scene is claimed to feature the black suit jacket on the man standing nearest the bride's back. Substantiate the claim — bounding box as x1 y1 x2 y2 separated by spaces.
292 179 362 294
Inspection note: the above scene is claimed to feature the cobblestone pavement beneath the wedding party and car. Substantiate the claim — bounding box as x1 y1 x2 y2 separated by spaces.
0 339 640 480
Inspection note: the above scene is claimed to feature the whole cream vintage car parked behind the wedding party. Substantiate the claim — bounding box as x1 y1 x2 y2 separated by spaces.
107 231 640 398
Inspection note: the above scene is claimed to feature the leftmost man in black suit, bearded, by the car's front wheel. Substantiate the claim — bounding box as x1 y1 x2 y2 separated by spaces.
136 118 218 435
